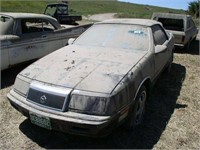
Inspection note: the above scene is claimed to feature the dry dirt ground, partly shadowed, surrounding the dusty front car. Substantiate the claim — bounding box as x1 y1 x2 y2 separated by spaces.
0 15 200 149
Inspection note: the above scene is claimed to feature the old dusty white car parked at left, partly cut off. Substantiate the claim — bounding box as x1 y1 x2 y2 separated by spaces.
0 13 91 70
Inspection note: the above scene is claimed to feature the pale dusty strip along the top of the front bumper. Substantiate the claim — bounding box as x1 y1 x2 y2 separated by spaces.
7 90 112 125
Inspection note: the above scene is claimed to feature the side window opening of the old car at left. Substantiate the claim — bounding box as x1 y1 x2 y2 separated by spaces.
21 18 55 34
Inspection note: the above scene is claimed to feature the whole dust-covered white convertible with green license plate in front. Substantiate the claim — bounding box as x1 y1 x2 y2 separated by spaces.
7 19 174 136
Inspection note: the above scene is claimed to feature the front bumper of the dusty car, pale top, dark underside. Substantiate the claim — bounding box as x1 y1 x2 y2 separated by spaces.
7 90 119 137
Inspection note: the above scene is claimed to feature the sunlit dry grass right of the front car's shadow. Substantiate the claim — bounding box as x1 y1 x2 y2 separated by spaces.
152 47 200 149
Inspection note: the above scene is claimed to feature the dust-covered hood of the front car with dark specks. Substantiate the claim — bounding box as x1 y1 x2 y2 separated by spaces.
20 45 147 93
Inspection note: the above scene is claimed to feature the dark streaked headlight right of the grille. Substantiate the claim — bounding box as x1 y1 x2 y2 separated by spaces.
69 95 109 115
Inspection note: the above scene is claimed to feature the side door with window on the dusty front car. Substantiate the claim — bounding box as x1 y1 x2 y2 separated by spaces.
152 25 171 76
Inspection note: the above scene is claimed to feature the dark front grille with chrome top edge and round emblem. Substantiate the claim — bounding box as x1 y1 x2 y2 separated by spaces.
27 82 70 111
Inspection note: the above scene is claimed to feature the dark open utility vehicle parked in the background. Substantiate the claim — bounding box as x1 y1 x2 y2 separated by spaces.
44 4 82 25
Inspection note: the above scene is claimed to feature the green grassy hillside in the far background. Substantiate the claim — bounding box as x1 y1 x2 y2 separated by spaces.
1 0 185 18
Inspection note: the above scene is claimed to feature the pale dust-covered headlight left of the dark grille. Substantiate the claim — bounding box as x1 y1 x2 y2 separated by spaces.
14 75 30 95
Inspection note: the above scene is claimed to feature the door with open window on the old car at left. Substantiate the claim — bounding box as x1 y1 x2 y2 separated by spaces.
9 18 62 65
